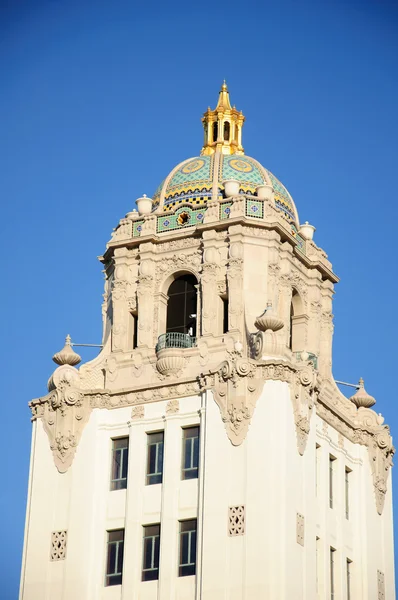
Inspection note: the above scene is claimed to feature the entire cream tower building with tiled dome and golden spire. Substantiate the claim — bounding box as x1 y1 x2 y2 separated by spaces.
20 83 395 600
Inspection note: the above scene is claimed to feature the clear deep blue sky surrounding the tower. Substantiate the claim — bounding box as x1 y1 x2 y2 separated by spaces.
0 0 398 600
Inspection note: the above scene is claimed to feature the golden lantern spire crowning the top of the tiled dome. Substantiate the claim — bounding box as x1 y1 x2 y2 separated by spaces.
201 79 245 155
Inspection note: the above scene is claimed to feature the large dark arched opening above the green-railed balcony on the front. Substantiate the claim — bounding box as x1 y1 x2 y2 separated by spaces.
166 275 198 336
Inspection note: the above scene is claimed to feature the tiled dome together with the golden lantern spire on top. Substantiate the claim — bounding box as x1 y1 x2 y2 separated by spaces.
152 81 299 228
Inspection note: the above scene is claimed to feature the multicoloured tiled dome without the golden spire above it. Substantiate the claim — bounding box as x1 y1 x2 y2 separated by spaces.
153 153 298 226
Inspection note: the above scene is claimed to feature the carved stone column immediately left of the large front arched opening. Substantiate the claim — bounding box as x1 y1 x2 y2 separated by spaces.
137 242 155 348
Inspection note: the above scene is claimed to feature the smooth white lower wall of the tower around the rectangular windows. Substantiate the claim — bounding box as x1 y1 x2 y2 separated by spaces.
20 381 395 600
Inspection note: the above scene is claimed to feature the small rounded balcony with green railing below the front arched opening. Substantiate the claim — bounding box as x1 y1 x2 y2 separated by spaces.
156 331 196 377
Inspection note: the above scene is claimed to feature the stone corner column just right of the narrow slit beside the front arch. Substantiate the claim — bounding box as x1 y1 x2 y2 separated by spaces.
227 225 245 343
